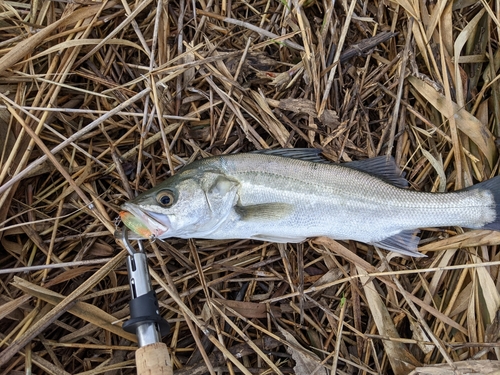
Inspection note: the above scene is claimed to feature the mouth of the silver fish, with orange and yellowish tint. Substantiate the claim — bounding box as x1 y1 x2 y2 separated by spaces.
120 203 171 239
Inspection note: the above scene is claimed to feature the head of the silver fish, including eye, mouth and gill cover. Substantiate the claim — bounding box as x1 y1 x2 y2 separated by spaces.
120 170 239 239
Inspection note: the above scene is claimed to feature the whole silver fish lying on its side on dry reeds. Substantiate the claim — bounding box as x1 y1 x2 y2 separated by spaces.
120 149 500 256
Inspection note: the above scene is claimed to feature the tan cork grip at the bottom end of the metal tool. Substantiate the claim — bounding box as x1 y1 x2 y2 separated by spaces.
135 342 174 375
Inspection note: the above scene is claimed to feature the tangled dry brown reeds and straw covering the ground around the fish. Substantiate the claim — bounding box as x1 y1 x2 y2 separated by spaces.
0 0 500 375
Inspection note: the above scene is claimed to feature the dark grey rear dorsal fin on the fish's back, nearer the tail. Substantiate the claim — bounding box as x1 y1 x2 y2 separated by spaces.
341 156 408 188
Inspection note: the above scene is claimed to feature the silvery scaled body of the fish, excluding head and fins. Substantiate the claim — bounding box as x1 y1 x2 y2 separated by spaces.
206 155 495 242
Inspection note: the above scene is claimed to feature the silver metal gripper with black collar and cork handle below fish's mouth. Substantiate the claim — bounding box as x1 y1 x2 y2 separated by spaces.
117 227 173 375
